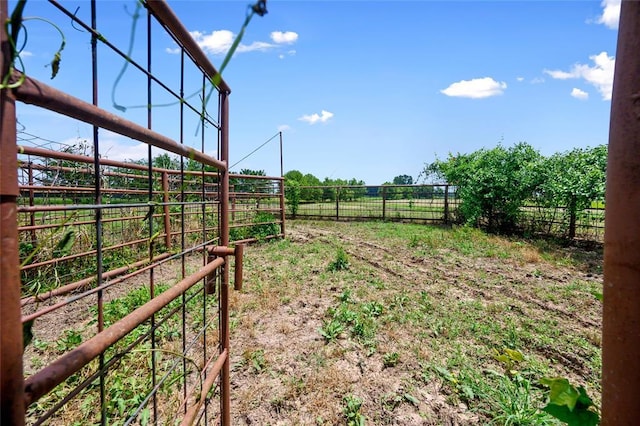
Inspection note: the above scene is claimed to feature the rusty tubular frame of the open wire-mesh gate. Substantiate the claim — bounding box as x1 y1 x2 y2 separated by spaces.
0 0 242 425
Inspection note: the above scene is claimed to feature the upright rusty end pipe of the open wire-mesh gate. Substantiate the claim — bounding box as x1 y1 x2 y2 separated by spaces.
220 92 231 426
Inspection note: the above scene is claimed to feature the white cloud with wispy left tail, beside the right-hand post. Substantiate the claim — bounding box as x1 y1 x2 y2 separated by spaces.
544 52 616 101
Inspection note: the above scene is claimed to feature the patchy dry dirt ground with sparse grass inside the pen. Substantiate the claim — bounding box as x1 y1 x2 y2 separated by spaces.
231 222 602 425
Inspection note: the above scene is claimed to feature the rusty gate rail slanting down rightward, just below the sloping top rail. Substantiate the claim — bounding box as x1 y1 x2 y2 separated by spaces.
12 72 226 170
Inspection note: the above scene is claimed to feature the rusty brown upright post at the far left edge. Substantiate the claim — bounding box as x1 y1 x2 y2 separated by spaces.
0 0 24 426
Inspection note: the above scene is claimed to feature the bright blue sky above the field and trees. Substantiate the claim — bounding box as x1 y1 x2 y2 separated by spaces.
10 0 619 185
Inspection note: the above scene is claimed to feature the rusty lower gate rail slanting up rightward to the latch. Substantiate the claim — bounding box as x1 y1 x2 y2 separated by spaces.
24 258 224 407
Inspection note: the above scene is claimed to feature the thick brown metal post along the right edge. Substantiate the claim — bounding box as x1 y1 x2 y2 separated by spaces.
602 0 640 426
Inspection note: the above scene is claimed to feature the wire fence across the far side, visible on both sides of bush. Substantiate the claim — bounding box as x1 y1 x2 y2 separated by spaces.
288 185 604 241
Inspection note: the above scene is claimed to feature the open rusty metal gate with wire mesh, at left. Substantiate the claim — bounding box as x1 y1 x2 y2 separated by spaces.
0 0 245 425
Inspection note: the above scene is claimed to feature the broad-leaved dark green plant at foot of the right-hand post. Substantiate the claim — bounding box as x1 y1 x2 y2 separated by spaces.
540 377 600 426
